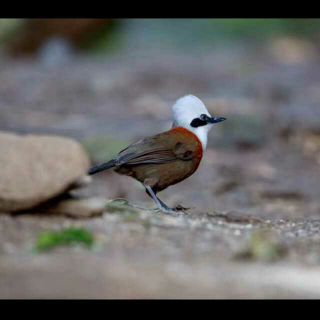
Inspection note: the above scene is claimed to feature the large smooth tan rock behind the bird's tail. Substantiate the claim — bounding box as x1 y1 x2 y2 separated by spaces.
0 132 89 212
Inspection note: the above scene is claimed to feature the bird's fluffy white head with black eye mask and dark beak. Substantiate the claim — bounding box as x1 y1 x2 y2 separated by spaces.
172 94 226 150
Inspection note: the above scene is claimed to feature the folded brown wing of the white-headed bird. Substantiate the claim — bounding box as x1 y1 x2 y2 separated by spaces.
115 132 193 166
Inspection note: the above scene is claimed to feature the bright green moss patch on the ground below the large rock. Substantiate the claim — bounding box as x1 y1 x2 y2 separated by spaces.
34 227 94 252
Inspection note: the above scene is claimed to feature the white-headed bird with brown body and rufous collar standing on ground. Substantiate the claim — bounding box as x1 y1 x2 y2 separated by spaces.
88 94 226 214
